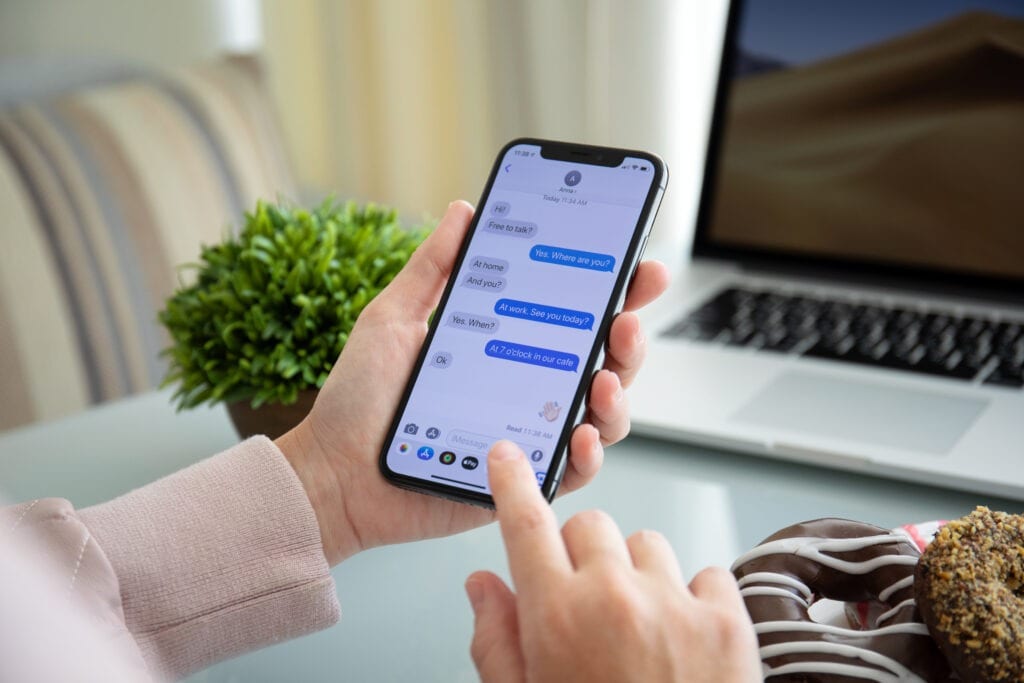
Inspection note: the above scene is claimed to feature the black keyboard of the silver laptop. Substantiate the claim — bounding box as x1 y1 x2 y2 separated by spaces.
664 288 1024 388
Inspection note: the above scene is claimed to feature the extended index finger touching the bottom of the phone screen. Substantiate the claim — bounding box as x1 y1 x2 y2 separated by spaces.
487 441 572 596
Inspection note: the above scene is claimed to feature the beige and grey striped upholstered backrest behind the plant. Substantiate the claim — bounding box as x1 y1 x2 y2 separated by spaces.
0 57 295 429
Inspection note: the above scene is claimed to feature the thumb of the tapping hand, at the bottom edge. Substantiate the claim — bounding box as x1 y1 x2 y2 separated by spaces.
466 571 525 683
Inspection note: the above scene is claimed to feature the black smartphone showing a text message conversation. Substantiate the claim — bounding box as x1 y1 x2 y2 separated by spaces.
380 139 668 507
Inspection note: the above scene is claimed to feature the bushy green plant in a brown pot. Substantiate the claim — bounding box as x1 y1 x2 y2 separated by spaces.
160 200 427 438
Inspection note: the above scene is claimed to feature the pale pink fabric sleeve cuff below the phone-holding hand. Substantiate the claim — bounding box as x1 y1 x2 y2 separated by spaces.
78 436 340 678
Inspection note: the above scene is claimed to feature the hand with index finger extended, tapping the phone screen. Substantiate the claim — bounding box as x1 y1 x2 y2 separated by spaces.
466 441 761 683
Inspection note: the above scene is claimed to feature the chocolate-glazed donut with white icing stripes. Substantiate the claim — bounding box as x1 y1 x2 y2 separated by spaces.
732 519 949 683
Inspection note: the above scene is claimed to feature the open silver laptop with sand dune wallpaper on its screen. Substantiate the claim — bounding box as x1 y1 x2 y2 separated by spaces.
631 0 1024 500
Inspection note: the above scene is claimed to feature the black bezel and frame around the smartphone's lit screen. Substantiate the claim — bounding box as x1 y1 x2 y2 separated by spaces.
378 137 669 509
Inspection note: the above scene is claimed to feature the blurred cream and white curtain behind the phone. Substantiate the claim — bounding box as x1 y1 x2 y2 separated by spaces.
263 0 725 255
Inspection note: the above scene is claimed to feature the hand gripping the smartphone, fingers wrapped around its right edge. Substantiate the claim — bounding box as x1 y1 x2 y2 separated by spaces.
276 202 669 564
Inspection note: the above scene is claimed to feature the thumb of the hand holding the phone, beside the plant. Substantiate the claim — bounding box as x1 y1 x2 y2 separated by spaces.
377 200 473 321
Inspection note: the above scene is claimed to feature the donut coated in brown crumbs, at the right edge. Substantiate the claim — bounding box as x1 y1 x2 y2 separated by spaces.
914 507 1024 682
